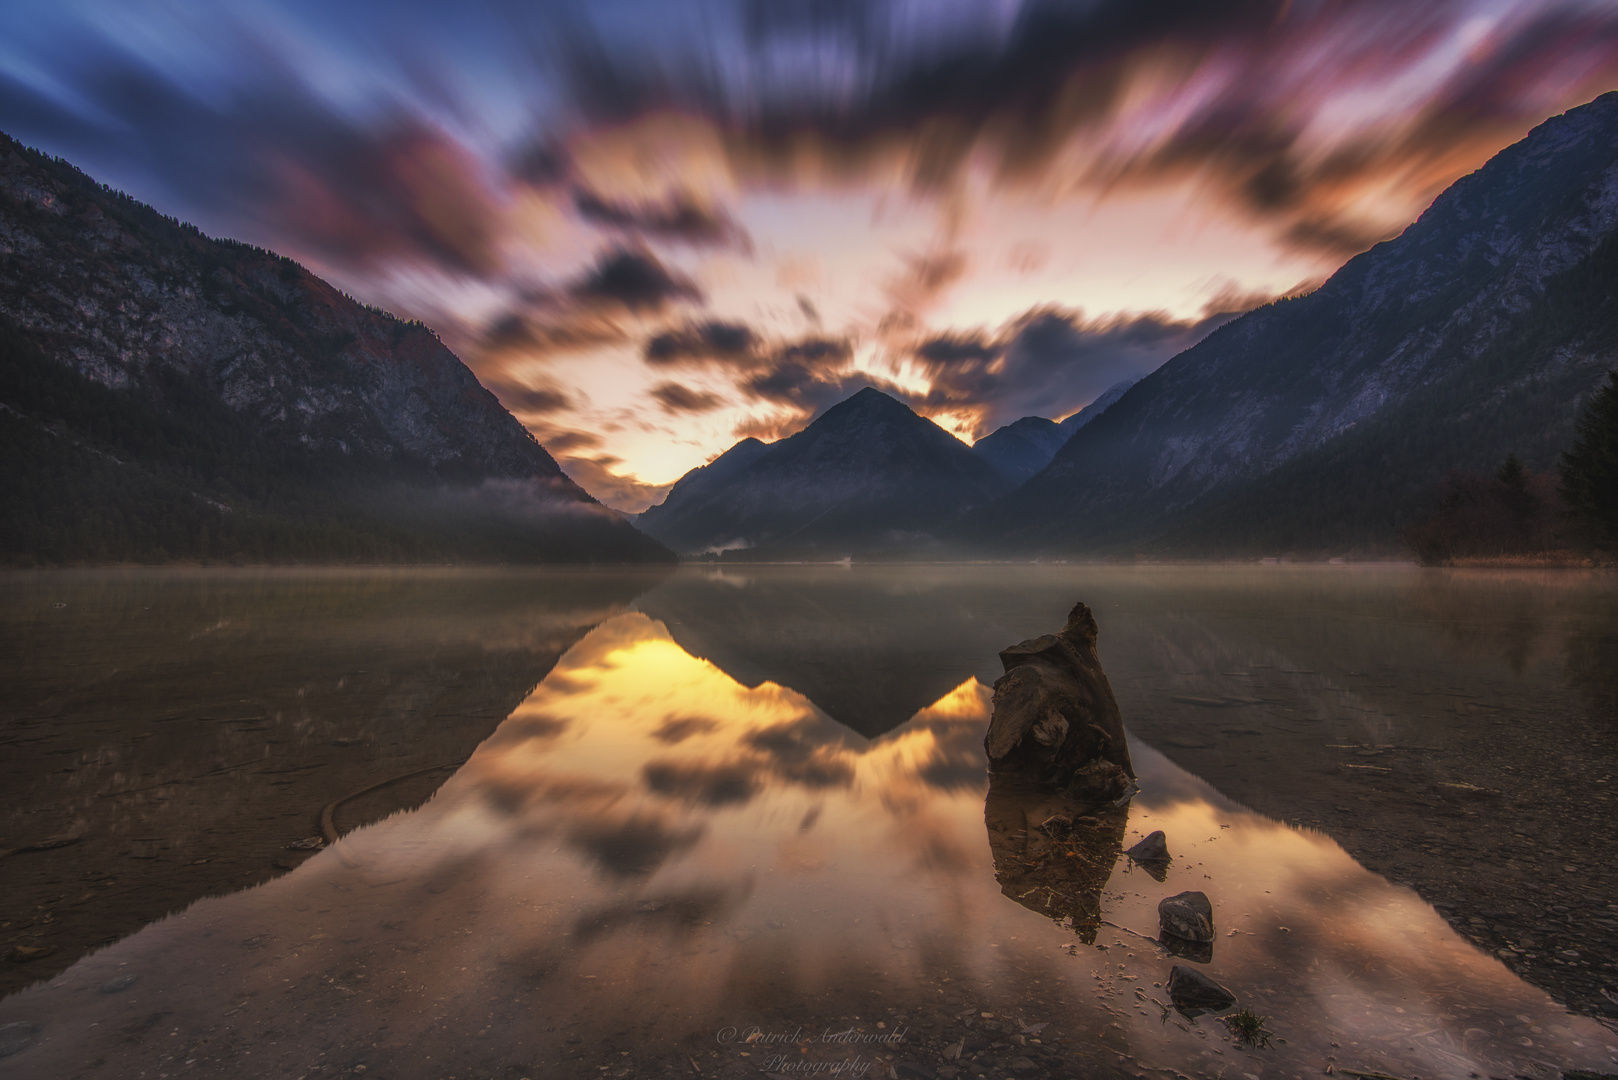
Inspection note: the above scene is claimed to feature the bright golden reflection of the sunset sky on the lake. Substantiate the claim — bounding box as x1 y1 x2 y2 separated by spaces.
0 582 1615 1078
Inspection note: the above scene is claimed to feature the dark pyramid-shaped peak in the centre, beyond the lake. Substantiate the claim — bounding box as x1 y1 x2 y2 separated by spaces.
641 387 1010 555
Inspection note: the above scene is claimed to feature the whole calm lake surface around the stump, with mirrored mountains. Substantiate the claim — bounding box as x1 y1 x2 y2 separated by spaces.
0 565 1618 1080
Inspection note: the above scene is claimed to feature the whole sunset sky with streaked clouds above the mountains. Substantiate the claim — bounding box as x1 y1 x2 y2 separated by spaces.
0 0 1618 512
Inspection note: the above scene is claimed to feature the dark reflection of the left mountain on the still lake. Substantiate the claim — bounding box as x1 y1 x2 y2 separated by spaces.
0 570 663 993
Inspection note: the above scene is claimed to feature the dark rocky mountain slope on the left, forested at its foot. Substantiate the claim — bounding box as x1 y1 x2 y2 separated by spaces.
0 136 670 563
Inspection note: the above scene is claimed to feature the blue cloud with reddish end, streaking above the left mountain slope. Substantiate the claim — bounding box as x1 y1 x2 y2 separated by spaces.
0 39 502 275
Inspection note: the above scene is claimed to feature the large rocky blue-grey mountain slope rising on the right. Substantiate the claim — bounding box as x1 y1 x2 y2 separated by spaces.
964 92 1618 555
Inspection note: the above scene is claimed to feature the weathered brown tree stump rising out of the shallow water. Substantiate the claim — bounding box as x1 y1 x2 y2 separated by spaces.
984 604 1134 805
